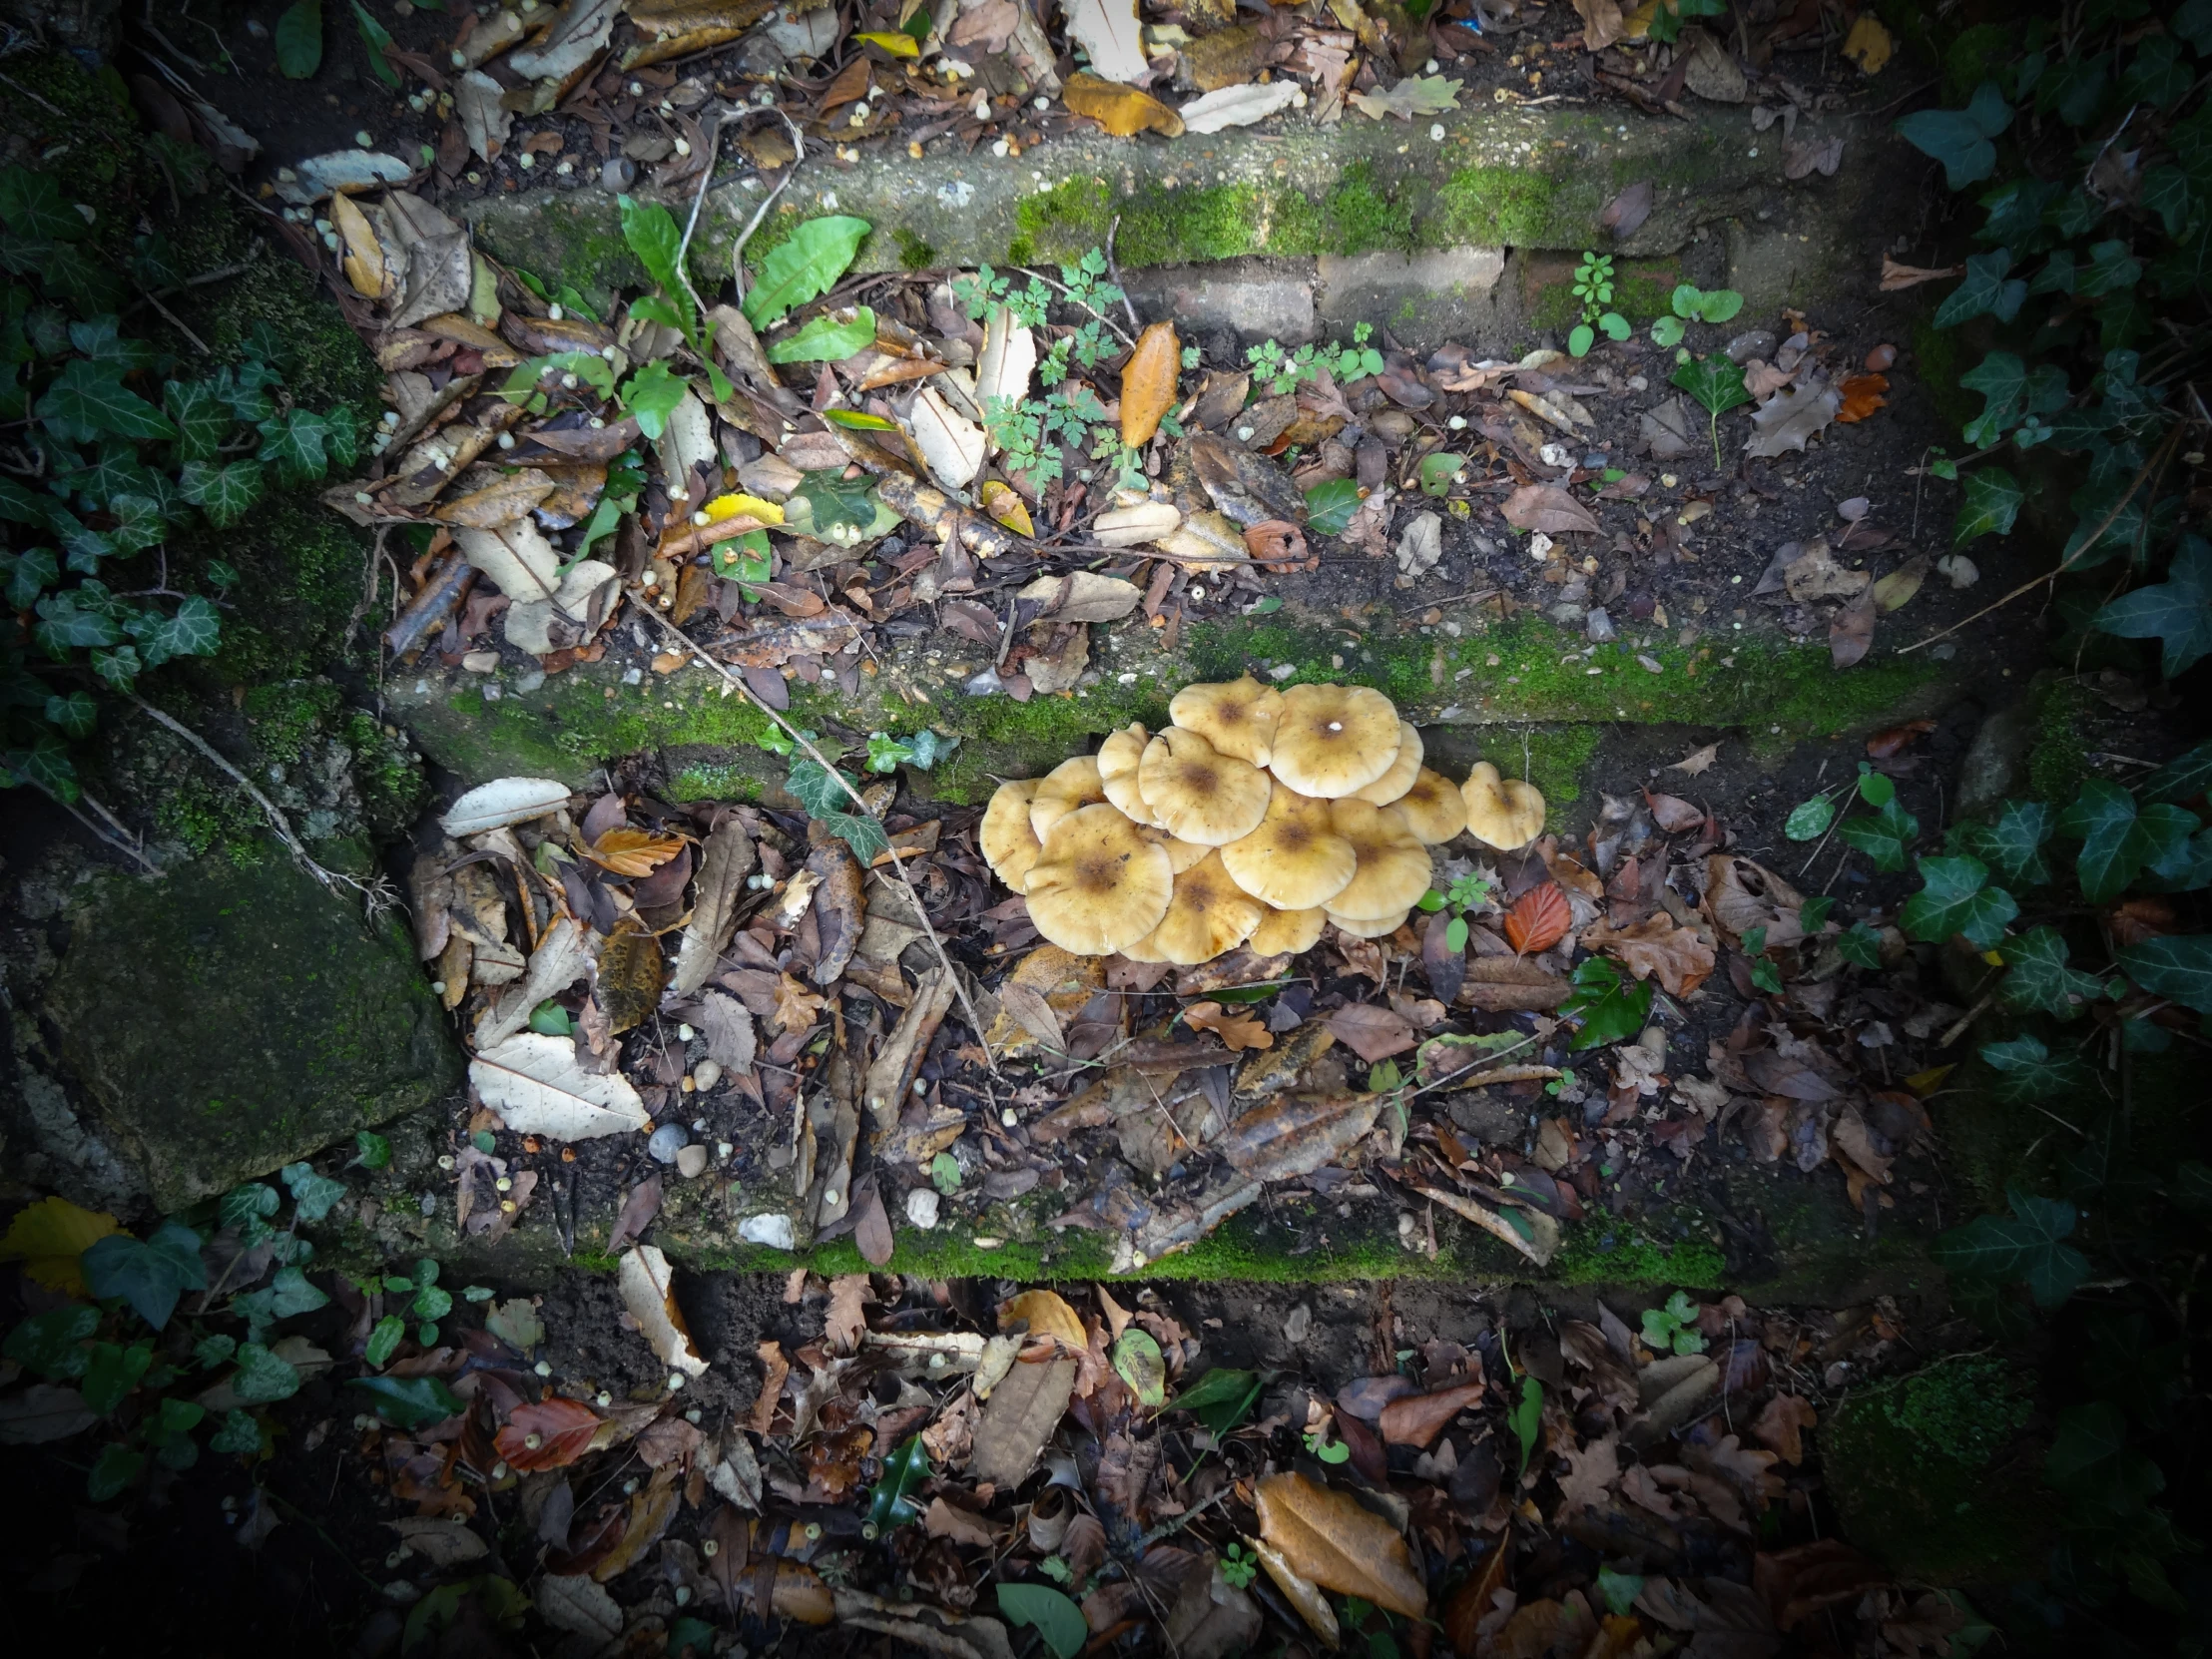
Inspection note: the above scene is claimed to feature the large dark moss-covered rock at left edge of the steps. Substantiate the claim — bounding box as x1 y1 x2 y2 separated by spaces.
40 849 460 1210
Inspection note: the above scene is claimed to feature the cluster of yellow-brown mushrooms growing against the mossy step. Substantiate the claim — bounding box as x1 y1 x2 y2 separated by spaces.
980 675 1544 966
